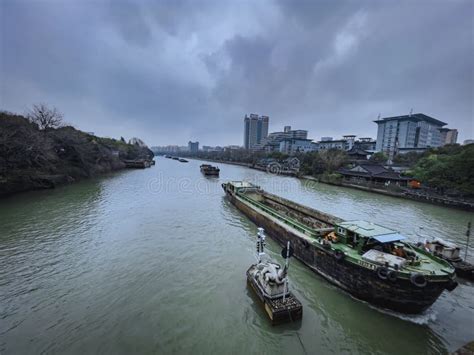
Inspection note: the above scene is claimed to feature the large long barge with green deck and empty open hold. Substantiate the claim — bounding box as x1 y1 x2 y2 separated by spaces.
222 181 457 314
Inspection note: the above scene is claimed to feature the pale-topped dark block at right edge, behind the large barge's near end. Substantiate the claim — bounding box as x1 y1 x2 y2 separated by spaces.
418 238 474 280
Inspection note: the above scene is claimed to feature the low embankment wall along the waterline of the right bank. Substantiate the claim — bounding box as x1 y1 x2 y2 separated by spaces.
186 158 474 211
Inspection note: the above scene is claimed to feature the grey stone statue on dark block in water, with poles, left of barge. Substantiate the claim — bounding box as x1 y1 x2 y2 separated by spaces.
247 228 303 325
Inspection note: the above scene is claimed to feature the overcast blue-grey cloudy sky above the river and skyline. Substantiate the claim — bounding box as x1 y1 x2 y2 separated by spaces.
0 0 474 145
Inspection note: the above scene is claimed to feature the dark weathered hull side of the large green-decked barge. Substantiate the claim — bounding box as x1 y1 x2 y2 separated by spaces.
230 193 447 314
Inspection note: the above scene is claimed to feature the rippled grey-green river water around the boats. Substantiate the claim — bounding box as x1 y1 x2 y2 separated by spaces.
0 157 474 354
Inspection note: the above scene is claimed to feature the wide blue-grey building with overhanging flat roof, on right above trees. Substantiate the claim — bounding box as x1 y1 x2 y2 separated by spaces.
374 113 446 158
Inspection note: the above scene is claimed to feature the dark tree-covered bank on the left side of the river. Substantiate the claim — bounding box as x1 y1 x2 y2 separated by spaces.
0 113 153 196
